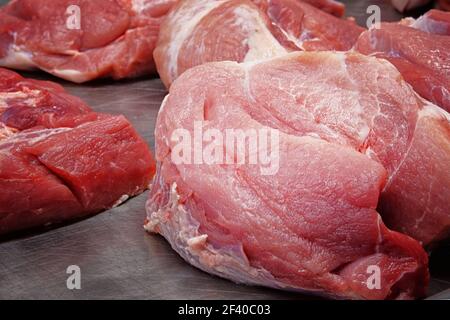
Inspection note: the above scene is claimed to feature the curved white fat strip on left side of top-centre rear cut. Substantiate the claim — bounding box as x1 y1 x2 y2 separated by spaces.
166 0 225 79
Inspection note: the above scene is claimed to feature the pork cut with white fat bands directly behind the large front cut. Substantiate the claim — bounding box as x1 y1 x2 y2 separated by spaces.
154 0 364 87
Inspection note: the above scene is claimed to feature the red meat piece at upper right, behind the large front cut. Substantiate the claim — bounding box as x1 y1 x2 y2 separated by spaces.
355 18 450 111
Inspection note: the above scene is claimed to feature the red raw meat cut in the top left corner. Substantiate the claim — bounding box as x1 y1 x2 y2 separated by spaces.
0 0 176 82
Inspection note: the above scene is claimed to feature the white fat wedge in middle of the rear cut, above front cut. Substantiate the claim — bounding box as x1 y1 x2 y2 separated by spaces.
233 6 287 62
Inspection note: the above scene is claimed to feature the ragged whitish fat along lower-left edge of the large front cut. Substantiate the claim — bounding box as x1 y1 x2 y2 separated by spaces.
144 181 348 295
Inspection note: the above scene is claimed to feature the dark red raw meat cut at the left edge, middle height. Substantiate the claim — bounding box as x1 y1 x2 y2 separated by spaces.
0 68 155 235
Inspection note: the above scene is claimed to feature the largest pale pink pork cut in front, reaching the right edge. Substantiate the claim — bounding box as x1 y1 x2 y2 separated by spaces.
145 52 442 299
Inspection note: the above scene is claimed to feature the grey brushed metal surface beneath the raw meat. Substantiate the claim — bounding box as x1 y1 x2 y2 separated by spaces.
0 0 450 299
